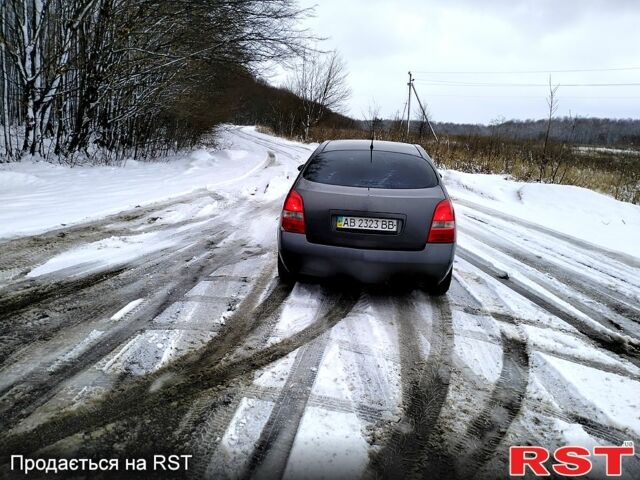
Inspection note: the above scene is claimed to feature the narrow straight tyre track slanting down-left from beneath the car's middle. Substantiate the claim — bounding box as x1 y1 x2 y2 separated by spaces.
242 291 359 479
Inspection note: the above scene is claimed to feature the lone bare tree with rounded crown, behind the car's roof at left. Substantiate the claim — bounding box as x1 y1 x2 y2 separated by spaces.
286 50 351 139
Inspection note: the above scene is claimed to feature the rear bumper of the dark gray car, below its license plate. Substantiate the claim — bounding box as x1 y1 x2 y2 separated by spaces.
278 229 455 283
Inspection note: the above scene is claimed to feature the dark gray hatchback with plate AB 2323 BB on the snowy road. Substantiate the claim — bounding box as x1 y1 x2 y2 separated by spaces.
278 140 456 295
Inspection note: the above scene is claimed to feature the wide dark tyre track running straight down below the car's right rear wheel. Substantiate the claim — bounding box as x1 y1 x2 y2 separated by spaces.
367 297 454 478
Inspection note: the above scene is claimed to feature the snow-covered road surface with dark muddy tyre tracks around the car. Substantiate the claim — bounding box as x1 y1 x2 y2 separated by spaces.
0 127 640 479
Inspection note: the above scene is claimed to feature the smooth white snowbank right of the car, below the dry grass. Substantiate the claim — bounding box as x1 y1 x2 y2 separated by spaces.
442 170 640 258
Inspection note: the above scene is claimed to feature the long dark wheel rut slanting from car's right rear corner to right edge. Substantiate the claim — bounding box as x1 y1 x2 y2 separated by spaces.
456 247 640 366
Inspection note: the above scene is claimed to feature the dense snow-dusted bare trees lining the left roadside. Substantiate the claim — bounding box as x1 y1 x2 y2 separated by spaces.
0 0 309 163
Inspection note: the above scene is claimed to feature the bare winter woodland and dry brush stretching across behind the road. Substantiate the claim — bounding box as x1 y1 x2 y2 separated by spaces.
0 0 640 203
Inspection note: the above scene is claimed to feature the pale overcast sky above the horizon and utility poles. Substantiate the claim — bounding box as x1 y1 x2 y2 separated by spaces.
278 0 640 123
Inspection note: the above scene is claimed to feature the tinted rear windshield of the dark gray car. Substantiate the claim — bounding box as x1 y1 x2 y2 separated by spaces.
303 150 438 189
